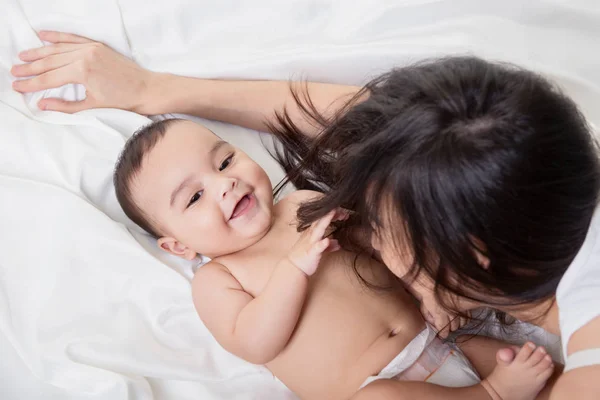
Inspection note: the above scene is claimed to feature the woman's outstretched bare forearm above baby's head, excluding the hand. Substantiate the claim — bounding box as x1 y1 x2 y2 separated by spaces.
143 74 360 136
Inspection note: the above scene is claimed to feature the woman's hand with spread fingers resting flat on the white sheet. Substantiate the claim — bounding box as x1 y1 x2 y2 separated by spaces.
11 31 153 114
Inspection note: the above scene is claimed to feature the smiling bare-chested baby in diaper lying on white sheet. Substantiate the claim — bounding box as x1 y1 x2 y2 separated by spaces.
115 119 553 400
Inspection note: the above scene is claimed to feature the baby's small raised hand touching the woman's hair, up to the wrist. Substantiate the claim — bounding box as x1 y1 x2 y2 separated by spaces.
288 210 348 276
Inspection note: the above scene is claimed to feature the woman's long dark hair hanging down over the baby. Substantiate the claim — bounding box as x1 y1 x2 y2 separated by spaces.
272 57 600 318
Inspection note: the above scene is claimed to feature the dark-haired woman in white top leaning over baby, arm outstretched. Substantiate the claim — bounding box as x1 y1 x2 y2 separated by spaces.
13 32 600 399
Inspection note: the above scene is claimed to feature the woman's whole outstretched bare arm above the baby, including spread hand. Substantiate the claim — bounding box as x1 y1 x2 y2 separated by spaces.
12 31 360 135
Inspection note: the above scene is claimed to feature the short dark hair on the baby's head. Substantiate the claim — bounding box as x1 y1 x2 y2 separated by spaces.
113 118 182 238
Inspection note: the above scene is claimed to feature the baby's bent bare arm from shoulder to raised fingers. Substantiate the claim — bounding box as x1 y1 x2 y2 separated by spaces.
192 213 339 364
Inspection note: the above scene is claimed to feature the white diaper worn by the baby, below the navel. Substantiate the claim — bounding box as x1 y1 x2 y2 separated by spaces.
361 325 481 388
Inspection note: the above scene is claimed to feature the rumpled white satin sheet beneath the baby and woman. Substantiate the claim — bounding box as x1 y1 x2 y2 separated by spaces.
0 0 600 400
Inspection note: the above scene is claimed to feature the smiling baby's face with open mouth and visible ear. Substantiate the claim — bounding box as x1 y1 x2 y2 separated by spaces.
131 121 273 258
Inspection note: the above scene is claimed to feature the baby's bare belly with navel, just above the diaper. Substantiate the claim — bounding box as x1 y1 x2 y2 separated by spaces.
267 253 425 400
